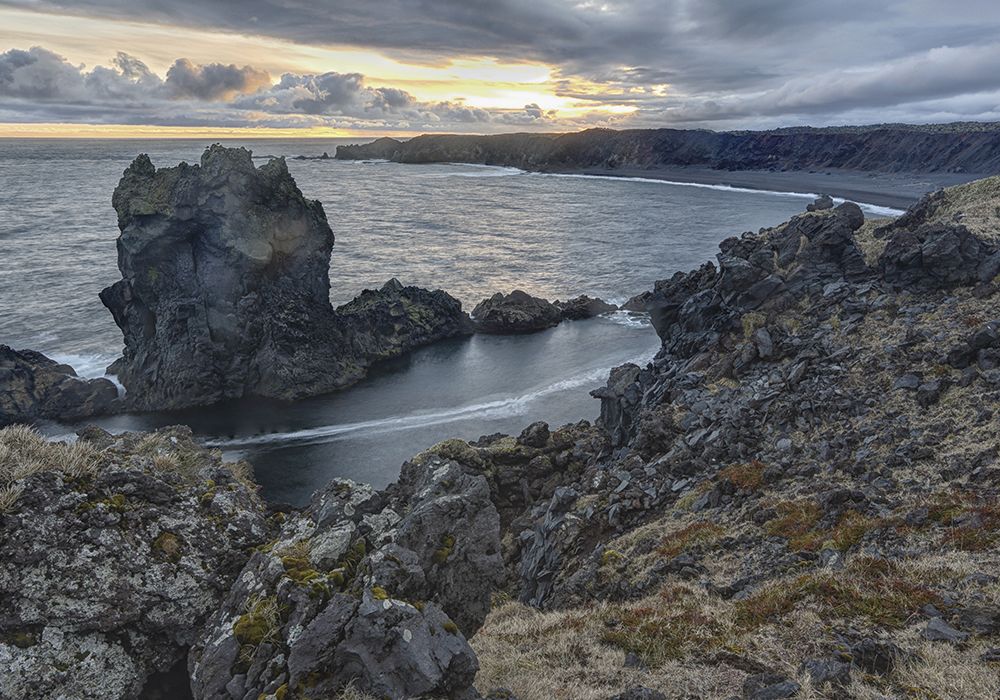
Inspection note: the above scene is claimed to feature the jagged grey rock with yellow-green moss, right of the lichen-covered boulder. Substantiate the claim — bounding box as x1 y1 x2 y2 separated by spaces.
189 456 503 698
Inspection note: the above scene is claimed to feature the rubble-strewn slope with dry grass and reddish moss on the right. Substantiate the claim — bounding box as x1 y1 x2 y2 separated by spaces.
458 181 1000 698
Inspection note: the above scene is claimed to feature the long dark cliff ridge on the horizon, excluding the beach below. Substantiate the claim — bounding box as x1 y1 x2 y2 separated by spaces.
337 122 1000 174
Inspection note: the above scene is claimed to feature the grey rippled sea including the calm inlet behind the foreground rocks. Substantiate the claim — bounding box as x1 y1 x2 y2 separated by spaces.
0 139 885 503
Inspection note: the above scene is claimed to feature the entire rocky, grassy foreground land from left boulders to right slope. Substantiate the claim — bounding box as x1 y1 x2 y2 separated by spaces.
0 178 1000 700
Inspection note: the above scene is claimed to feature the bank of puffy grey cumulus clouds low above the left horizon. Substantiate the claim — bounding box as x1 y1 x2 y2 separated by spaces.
0 47 555 130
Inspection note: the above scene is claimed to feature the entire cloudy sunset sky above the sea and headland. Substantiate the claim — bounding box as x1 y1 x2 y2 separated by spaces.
0 0 1000 137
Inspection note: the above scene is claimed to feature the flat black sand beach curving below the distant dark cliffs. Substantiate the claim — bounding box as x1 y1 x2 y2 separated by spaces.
551 167 993 209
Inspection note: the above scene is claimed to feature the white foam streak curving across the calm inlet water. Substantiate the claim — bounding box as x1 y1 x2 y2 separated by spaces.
204 354 649 450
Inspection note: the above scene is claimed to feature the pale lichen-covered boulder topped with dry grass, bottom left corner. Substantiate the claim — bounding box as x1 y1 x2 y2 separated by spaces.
0 427 269 698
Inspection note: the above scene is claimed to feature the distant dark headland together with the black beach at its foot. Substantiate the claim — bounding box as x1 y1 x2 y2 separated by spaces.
336 123 1000 208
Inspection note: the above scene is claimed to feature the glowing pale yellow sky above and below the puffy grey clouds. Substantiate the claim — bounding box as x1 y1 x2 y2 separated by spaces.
0 5 635 136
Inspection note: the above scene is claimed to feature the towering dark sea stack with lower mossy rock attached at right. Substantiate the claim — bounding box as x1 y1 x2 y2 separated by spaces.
101 146 467 409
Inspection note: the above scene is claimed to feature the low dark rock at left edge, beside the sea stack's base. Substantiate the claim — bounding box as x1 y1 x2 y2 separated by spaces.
0 345 120 426
